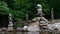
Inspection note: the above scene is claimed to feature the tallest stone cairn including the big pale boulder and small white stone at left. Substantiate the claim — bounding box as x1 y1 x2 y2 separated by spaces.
24 4 48 31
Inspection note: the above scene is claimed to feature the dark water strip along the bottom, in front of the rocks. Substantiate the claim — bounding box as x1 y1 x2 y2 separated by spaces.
0 31 60 34
